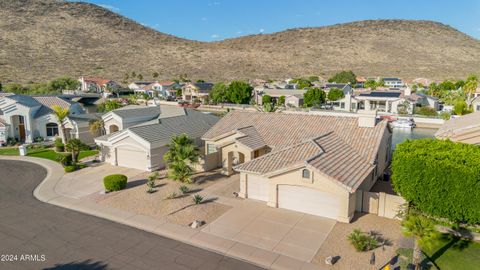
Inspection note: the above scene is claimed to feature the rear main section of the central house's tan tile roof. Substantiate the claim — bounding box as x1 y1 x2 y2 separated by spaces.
202 111 387 163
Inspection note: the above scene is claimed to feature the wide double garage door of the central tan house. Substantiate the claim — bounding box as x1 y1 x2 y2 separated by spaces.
278 185 340 219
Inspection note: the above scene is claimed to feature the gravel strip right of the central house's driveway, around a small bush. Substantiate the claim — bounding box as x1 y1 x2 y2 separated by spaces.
312 213 402 269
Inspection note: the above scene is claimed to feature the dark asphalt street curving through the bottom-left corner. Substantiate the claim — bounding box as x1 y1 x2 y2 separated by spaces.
0 160 258 270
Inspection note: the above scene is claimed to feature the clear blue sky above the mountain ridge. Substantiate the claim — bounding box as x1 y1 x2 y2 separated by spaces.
79 0 480 41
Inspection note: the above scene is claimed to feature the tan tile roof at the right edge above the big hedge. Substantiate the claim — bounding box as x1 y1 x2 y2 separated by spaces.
435 111 480 138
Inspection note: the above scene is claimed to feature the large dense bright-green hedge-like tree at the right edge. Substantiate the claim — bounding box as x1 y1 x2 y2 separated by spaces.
392 139 480 224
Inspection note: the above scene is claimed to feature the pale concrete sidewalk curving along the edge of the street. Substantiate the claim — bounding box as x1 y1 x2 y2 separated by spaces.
0 156 322 270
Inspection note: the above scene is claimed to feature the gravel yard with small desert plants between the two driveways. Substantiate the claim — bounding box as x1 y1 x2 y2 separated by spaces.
95 172 231 226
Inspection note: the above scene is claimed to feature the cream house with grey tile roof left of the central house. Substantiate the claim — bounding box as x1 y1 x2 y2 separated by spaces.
95 105 218 171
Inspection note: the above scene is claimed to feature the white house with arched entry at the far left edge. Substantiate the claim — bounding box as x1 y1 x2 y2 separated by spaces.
0 95 83 143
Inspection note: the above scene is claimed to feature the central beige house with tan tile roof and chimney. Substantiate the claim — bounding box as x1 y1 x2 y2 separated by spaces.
202 111 392 222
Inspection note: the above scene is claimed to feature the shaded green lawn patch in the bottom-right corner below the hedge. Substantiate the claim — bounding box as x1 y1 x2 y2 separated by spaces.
425 234 480 270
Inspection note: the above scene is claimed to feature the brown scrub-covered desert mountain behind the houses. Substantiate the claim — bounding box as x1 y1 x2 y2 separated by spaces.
0 0 480 83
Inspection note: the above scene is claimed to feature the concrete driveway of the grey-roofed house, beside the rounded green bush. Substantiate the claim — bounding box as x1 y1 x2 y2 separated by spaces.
55 163 148 199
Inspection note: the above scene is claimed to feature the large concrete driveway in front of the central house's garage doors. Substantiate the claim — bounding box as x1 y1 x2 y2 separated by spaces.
202 200 336 262
